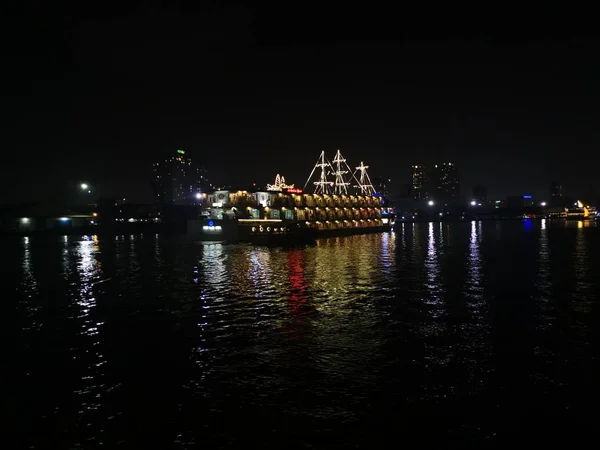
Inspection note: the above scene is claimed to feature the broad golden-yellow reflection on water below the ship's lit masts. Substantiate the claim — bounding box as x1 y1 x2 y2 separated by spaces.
308 234 386 379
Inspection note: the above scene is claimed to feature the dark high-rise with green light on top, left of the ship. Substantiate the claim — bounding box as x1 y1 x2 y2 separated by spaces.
152 150 213 205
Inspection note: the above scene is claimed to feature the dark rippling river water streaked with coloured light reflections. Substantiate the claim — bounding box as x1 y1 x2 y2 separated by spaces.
5 221 600 448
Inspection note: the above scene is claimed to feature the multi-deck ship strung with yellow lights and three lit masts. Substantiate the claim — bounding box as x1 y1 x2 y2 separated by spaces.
188 150 394 243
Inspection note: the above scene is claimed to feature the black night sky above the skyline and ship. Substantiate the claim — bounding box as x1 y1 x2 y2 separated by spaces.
0 1 600 203
